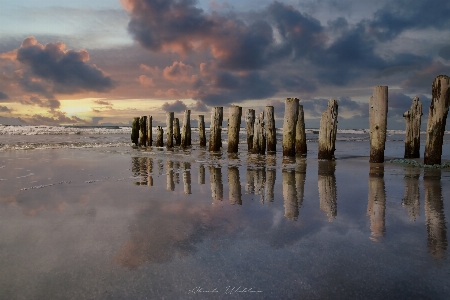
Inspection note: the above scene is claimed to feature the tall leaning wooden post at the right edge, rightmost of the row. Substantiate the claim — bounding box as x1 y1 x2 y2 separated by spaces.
424 75 450 165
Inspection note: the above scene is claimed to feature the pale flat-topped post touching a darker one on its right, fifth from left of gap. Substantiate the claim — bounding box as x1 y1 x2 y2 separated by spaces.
283 98 299 157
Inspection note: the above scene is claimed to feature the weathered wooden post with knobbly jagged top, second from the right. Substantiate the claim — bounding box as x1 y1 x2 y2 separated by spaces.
403 97 422 158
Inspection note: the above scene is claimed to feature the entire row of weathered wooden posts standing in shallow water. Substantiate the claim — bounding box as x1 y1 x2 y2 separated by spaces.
131 75 450 165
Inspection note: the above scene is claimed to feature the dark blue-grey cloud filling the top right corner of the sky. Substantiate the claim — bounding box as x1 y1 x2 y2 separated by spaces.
369 0 450 40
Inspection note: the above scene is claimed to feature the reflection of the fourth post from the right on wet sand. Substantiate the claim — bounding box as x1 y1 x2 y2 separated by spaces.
317 160 337 222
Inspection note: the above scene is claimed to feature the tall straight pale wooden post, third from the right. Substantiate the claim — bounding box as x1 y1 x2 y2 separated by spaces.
369 86 388 163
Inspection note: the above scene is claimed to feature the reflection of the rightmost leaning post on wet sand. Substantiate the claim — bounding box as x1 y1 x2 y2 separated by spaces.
423 169 448 258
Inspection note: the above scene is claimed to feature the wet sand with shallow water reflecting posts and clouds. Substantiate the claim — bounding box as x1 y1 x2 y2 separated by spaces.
0 141 450 299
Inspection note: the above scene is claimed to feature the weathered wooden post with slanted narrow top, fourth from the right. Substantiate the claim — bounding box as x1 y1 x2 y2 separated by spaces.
318 99 338 160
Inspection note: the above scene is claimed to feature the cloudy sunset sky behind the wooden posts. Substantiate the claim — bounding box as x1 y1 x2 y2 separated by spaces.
0 0 450 129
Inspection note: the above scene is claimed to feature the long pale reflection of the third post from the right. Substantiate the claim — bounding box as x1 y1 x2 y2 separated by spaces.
367 163 386 241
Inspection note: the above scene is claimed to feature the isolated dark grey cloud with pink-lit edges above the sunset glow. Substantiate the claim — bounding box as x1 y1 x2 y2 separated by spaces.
17 37 114 94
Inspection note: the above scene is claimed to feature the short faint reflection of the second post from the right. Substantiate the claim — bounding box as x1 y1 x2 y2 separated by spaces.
402 167 420 221
